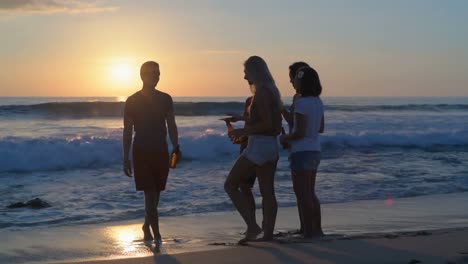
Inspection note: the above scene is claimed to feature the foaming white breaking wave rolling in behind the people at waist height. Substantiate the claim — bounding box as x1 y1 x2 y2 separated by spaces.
0 128 468 172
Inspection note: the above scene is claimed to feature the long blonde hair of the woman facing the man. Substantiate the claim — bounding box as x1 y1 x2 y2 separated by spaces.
244 56 283 109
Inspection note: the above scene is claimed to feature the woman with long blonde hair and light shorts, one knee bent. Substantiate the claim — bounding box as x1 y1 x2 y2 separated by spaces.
224 56 283 241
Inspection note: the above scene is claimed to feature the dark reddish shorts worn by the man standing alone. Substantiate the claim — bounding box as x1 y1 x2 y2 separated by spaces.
133 148 169 191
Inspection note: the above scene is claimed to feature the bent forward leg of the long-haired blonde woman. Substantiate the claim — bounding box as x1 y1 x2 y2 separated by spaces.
224 156 262 238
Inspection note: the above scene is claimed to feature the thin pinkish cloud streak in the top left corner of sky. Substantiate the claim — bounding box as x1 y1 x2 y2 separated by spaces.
0 0 117 14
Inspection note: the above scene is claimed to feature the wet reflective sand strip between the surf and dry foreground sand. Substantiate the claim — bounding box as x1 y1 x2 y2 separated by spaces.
0 192 468 263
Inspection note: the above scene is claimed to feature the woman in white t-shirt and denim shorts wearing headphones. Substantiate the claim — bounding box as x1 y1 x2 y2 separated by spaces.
280 67 324 237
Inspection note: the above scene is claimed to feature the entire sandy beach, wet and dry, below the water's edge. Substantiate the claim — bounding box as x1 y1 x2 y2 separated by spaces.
0 193 468 263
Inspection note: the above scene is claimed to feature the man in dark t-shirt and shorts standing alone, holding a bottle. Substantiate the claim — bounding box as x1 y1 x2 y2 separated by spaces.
123 61 179 245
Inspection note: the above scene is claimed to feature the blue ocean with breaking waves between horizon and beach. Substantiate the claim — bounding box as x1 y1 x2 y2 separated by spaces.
0 97 468 230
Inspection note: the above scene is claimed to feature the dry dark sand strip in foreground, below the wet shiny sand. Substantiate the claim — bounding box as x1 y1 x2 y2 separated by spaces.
78 229 468 264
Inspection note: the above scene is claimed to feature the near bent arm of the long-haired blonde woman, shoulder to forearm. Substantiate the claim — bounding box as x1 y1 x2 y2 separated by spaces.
244 91 273 135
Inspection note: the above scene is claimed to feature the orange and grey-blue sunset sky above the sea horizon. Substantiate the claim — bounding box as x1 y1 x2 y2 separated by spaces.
0 0 468 96
